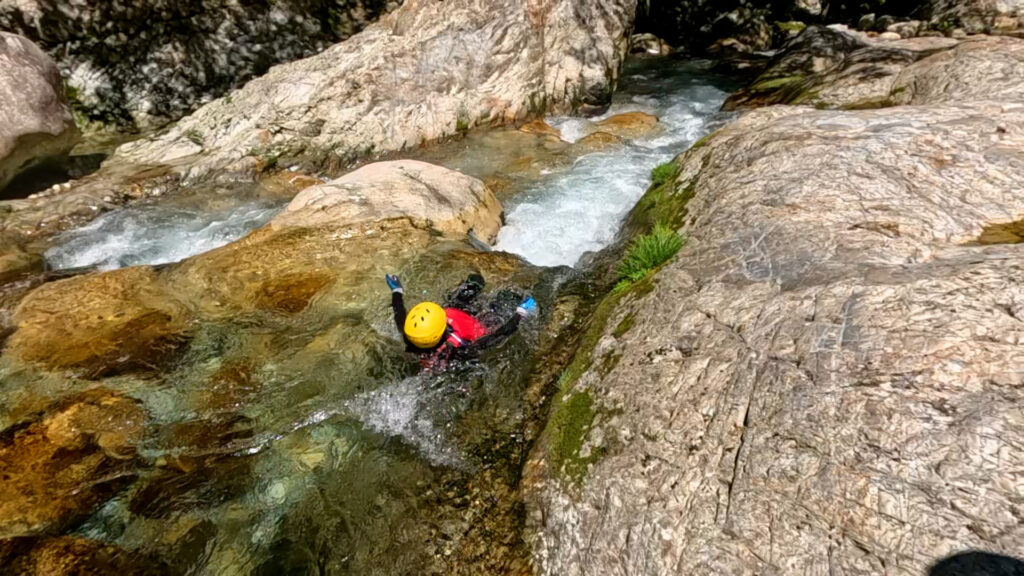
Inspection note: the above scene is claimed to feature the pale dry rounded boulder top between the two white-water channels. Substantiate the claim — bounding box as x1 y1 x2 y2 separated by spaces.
270 160 502 242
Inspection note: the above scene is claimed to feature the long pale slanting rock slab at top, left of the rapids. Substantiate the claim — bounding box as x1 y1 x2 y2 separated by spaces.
118 0 635 178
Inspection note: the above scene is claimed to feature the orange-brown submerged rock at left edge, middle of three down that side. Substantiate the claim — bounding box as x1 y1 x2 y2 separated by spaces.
0 389 145 539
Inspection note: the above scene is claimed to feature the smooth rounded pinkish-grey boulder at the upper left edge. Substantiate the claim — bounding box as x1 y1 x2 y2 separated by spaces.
0 32 78 192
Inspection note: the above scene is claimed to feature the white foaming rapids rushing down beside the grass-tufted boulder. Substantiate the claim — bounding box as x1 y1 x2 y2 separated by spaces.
496 60 729 265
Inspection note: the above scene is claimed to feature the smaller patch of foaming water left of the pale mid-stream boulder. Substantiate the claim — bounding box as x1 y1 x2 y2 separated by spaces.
45 195 281 270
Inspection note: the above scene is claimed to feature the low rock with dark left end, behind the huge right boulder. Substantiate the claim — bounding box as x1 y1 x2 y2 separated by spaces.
724 27 1024 110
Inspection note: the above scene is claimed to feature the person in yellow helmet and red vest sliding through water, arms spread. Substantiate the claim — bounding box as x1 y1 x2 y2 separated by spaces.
385 274 537 370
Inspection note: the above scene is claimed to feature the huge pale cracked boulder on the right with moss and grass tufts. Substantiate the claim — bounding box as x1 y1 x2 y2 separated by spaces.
525 102 1024 576
